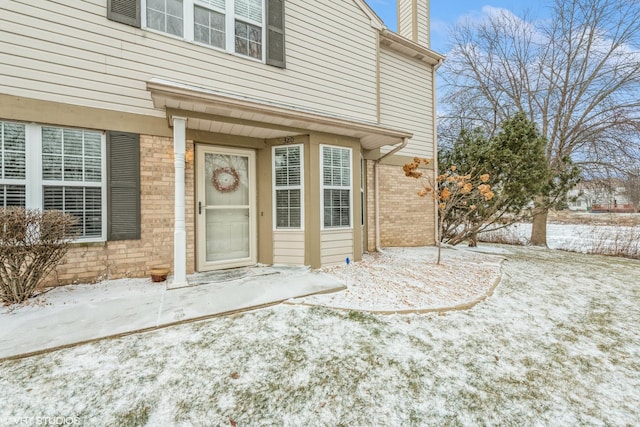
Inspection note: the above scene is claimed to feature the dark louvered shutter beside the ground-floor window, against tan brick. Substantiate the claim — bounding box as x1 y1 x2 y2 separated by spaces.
107 131 140 240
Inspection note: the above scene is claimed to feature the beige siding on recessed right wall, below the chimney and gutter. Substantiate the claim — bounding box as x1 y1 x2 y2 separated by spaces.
380 48 433 158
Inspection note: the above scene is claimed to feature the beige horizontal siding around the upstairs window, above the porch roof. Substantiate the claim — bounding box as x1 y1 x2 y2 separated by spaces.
0 0 376 122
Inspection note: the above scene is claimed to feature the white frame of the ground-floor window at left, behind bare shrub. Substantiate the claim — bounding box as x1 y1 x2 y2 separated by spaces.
0 120 107 242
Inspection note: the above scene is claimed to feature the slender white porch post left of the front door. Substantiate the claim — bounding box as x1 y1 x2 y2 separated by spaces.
172 117 187 287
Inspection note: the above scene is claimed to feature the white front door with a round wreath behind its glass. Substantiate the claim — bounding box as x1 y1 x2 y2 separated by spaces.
196 145 256 271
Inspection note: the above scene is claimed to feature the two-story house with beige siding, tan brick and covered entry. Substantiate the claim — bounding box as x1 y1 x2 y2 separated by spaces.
0 0 443 283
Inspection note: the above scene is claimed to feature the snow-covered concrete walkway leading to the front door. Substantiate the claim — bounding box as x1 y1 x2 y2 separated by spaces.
0 267 345 360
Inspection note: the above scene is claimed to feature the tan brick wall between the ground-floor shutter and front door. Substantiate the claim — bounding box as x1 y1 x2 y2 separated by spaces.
45 135 195 286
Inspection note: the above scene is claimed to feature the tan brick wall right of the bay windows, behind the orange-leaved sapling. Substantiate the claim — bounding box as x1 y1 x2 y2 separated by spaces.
367 161 435 251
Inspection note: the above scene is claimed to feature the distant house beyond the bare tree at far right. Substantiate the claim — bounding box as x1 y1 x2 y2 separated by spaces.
568 178 634 213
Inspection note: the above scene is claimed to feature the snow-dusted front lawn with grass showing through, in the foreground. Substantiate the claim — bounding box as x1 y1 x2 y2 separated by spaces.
0 248 640 426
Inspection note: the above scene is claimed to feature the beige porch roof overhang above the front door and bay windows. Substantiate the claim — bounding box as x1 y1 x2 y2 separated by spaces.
147 78 413 150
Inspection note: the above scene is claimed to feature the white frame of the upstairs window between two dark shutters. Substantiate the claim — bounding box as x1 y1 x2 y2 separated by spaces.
140 0 267 63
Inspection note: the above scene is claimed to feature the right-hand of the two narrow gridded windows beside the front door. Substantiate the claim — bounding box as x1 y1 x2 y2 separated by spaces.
321 146 351 228
